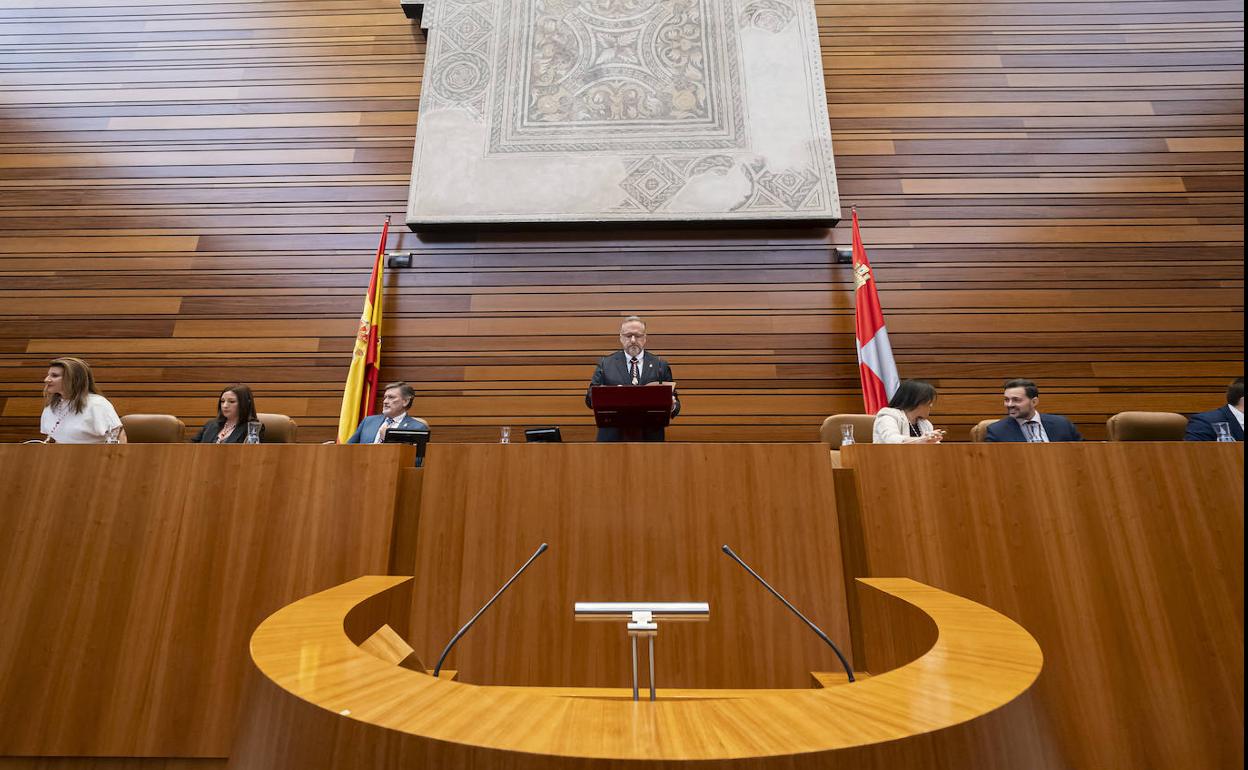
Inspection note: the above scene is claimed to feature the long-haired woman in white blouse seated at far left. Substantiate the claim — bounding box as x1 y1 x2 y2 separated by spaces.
39 357 126 444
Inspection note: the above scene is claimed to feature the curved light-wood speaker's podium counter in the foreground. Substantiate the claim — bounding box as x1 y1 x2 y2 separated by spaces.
231 577 1042 768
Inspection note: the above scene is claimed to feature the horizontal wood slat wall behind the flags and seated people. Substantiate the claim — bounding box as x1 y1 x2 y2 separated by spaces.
0 0 1244 441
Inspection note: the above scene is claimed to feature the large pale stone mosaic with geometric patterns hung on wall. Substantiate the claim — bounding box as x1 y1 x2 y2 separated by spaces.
407 0 840 228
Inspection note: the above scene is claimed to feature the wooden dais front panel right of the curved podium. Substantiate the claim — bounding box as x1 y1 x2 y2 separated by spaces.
836 443 1244 769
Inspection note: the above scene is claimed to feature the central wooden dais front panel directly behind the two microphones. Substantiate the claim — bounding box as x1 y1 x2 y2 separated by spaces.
398 443 851 689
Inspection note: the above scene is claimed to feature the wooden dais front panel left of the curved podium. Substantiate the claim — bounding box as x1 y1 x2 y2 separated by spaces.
0 444 412 758
